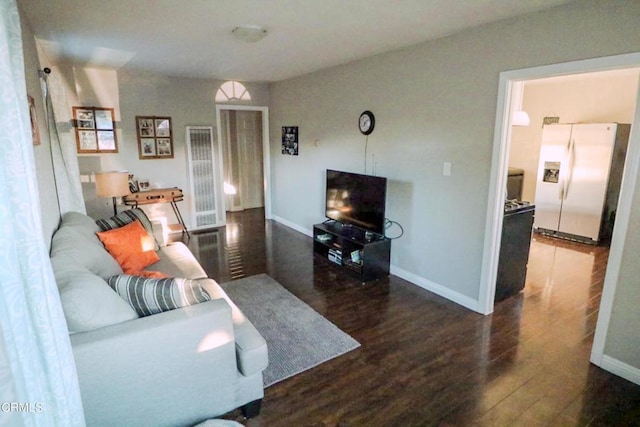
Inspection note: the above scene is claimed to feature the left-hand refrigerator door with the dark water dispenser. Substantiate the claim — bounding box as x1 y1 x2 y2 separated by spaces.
533 125 571 231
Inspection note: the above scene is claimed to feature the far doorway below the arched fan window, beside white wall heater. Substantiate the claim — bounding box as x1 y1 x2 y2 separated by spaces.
216 105 271 219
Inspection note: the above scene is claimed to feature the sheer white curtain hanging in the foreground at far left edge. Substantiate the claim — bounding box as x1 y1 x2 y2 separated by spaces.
0 0 84 426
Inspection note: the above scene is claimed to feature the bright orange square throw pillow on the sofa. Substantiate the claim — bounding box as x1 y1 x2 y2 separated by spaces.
96 221 160 274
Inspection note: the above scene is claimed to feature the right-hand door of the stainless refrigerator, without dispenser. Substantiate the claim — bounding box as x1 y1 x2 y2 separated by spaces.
559 123 616 241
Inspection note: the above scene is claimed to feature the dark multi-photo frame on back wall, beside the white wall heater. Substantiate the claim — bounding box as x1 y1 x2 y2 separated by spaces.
136 116 173 160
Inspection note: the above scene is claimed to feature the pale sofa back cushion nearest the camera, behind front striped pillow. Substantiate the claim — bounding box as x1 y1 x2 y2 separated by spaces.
51 257 138 334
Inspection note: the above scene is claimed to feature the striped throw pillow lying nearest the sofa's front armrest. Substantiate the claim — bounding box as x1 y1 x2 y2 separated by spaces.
107 274 211 316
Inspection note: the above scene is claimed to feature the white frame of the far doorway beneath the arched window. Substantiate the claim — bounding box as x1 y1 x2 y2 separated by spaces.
216 104 272 224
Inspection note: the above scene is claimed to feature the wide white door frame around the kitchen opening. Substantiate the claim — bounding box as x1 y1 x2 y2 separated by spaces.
478 53 640 366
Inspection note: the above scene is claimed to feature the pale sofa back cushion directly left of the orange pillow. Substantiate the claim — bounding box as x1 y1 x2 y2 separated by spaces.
51 212 122 279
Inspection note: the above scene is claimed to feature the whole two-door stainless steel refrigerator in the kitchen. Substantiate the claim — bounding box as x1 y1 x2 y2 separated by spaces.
533 123 631 243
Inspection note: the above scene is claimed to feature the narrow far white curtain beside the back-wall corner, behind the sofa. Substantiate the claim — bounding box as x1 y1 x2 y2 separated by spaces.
42 73 86 216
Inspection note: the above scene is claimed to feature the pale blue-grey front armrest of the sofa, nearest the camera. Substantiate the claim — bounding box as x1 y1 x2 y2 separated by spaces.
70 299 238 426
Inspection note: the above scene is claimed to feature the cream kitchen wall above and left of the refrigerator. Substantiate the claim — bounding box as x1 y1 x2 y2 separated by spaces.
509 70 640 201
